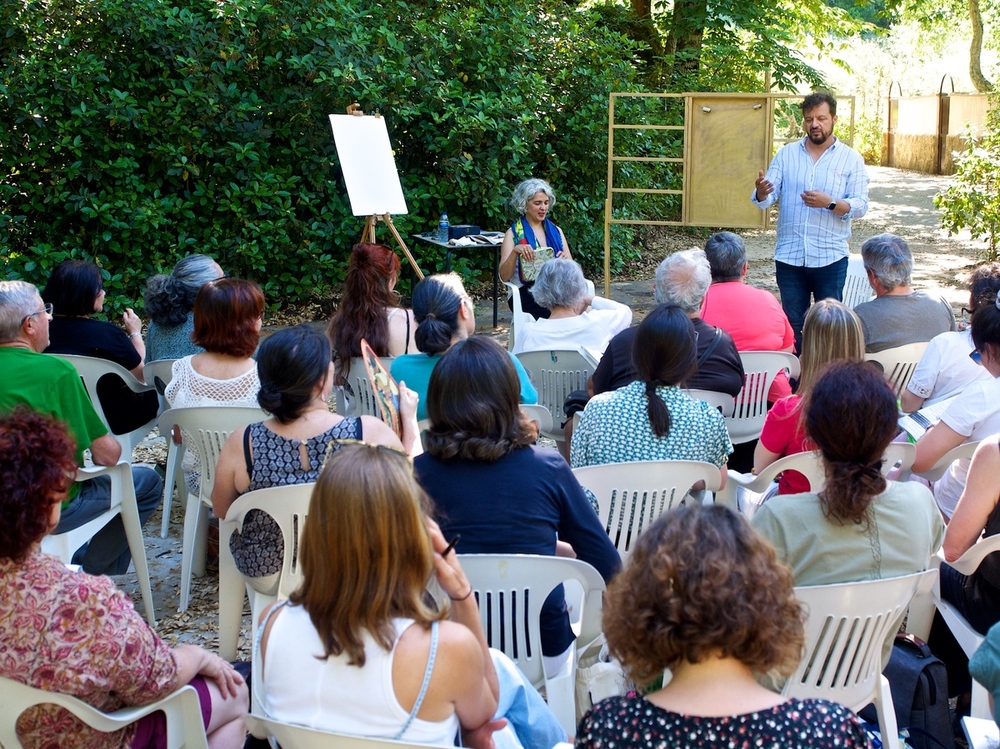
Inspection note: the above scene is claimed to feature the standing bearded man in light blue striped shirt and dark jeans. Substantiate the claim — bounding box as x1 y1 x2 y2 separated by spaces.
750 92 868 350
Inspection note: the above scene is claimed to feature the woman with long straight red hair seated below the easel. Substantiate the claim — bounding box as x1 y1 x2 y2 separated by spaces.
326 242 417 385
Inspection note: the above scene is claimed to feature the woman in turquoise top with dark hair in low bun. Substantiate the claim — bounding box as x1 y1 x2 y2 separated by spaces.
392 273 538 420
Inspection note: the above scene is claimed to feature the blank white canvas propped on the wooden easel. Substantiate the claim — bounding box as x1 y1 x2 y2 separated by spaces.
330 114 407 216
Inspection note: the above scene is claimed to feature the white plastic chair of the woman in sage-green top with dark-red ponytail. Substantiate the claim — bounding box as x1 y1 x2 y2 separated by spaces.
782 569 937 749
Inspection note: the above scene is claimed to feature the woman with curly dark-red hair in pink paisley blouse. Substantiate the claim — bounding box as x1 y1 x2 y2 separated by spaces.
0 408 247 749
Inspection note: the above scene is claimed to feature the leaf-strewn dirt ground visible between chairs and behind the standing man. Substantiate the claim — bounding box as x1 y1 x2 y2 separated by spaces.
118 167 983 658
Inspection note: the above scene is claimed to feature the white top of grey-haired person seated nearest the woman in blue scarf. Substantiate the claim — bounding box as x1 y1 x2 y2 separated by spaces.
513 296 632 361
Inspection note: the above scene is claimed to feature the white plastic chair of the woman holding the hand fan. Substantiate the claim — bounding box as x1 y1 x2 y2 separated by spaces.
219 483 315 661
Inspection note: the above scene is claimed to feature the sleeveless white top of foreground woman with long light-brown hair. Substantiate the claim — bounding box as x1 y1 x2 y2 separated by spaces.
261 604 459 747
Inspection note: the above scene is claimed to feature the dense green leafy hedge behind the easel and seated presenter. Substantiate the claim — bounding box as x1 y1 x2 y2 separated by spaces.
0 0 635 307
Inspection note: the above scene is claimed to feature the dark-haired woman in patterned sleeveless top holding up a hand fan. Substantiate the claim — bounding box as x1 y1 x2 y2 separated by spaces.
212 324 420 592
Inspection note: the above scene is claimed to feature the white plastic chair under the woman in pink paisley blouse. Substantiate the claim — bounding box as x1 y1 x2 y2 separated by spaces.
0 677 208 749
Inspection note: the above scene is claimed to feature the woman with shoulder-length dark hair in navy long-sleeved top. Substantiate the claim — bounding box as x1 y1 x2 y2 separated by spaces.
413 337 621 676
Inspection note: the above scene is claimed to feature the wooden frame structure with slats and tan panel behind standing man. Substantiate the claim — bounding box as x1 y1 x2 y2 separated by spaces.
604 92 855 296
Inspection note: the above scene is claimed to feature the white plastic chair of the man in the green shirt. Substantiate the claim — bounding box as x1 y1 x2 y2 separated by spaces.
42 456 156 627
